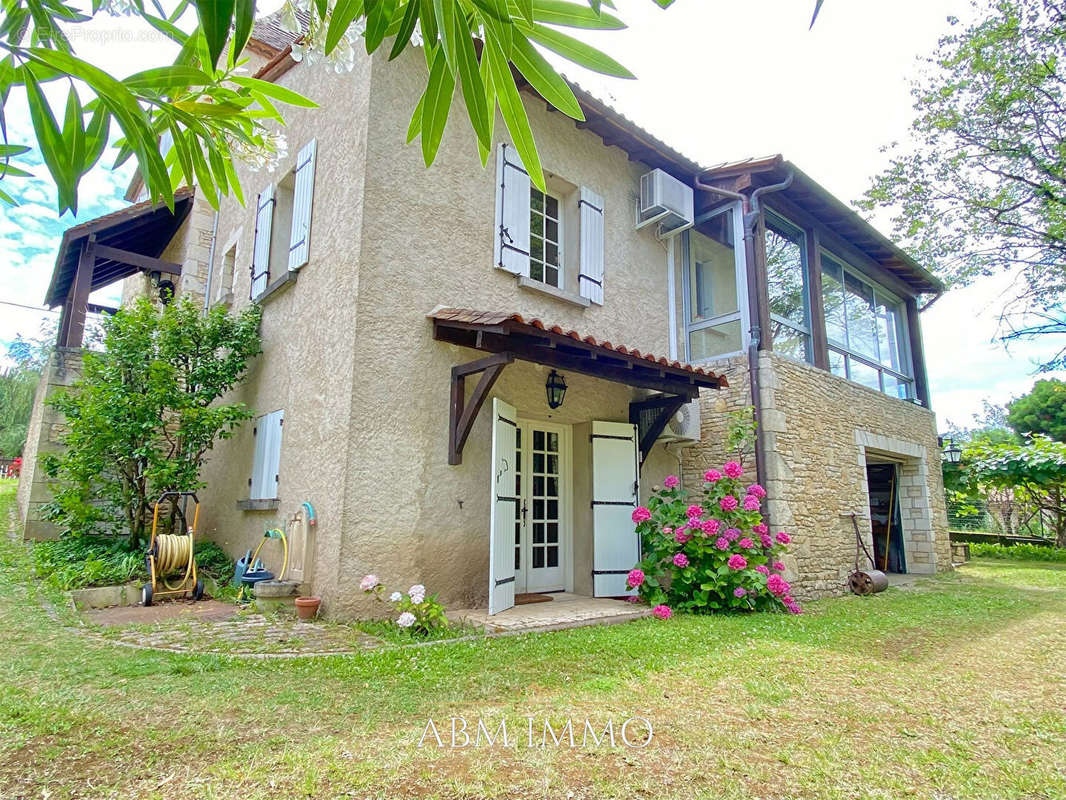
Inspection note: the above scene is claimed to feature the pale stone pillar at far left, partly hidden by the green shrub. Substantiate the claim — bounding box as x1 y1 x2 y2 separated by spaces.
16 348 82 540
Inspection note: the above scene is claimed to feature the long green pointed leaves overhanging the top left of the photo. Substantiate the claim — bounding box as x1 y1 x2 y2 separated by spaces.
0 0 823 214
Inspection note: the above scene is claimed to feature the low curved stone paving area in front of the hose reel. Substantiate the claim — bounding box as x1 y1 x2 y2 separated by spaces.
86 601 383 658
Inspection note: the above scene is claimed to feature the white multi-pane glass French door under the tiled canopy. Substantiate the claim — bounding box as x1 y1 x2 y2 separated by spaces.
515 422 568 592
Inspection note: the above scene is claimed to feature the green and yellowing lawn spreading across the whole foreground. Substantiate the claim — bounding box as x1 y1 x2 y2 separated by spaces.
0 484 1066 800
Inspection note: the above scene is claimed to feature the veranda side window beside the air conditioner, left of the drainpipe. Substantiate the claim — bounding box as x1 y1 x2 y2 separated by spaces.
678 206 748 362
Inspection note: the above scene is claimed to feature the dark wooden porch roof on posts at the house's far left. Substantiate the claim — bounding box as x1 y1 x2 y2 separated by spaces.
45 188 193 348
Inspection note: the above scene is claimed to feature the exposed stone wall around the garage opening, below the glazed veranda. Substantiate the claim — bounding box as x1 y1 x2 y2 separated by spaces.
682 353 951 598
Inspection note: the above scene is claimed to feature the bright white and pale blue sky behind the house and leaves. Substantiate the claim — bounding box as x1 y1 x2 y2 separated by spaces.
0 0 1066 430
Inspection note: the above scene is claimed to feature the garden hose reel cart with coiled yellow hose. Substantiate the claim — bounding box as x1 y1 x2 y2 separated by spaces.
141 492 204 606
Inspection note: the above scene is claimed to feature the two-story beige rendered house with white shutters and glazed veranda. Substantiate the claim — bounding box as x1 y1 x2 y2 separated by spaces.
23 18 950 617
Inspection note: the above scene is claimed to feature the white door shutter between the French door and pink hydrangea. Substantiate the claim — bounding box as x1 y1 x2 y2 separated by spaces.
592 421 641 597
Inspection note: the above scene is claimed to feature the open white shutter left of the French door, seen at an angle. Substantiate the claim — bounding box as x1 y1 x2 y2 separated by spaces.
488 397 519 614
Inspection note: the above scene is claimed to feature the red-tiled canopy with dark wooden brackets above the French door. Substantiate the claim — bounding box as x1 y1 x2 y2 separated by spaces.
429 308 729 464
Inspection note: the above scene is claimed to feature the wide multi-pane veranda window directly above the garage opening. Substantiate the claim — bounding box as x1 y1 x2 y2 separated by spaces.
822 253 914 399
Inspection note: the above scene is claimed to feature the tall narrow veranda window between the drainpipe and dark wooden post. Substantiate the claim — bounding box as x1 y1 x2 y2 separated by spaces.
765 213 814 362
